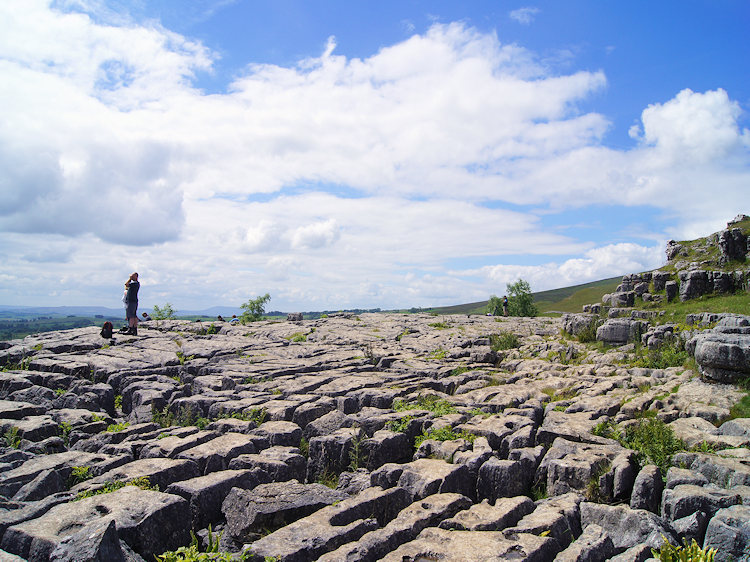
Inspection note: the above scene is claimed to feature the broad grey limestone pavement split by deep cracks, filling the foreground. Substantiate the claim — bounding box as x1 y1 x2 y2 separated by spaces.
0 314 750 562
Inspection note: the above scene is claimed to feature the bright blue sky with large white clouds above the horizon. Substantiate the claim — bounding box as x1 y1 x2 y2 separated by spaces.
0 0 750 311
